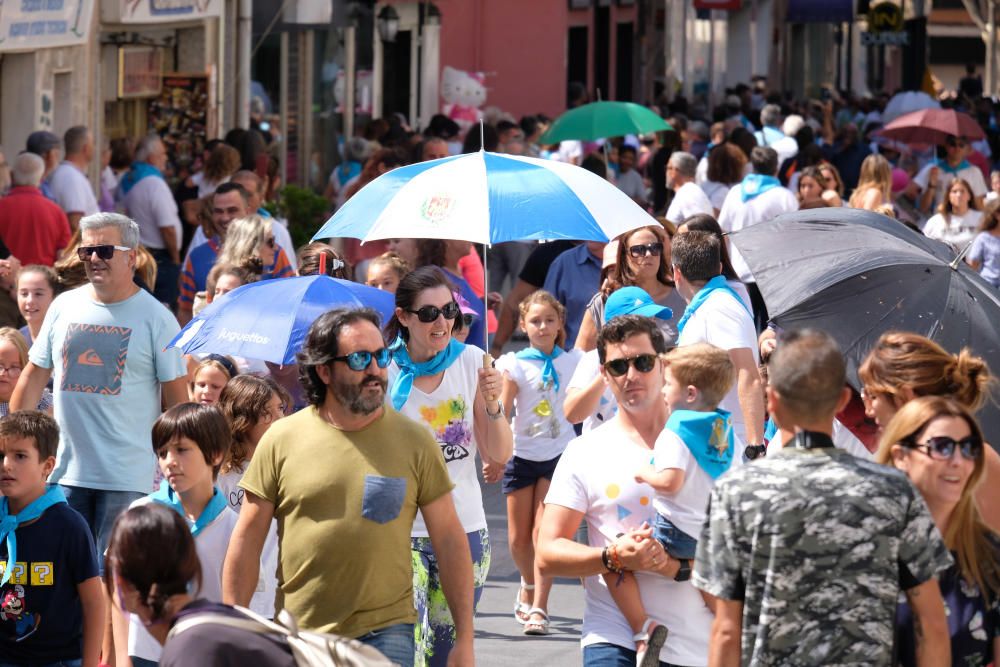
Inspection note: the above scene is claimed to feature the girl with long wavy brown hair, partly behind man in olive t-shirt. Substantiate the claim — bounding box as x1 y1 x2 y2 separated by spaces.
216 375 291 618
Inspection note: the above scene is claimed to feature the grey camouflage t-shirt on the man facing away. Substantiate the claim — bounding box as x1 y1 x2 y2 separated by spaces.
693 447 952 667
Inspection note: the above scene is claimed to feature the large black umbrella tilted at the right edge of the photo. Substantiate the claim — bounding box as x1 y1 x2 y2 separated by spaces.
731 208 1000 441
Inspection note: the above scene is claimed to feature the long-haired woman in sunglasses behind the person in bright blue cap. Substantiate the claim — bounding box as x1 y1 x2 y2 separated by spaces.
575 225 687 352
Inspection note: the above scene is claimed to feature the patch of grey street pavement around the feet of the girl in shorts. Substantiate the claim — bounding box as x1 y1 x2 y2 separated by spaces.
476 468 583 667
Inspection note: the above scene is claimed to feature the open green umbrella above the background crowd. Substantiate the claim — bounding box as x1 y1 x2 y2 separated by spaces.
539 102 674 144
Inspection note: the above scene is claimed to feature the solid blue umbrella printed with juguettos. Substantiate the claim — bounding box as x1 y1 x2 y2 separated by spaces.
168 276 395 364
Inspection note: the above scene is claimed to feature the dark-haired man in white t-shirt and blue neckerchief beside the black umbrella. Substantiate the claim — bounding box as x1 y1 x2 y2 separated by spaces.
671 232 764 462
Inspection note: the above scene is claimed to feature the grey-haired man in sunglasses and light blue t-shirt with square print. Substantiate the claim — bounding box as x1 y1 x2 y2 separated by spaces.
10 213 187 554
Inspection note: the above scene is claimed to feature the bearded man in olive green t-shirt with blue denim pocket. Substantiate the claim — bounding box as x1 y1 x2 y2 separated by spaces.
222 309 473 666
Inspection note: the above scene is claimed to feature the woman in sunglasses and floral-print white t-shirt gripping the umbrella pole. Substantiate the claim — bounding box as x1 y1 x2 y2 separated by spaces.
385 266 513 665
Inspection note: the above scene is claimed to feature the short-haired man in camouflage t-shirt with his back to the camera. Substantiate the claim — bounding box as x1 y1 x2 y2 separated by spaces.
692 329 952 667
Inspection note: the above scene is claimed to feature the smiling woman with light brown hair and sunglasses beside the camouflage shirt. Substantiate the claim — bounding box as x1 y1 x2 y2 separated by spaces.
876 396 1000 667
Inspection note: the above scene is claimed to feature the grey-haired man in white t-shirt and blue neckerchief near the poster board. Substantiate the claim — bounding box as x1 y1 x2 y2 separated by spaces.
118 134 183 310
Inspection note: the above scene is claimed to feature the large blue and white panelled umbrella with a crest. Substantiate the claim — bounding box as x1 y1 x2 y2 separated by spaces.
313 151 657 244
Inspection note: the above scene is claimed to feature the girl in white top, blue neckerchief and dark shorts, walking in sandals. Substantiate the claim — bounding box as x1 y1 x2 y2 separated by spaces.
497 290 583 635
